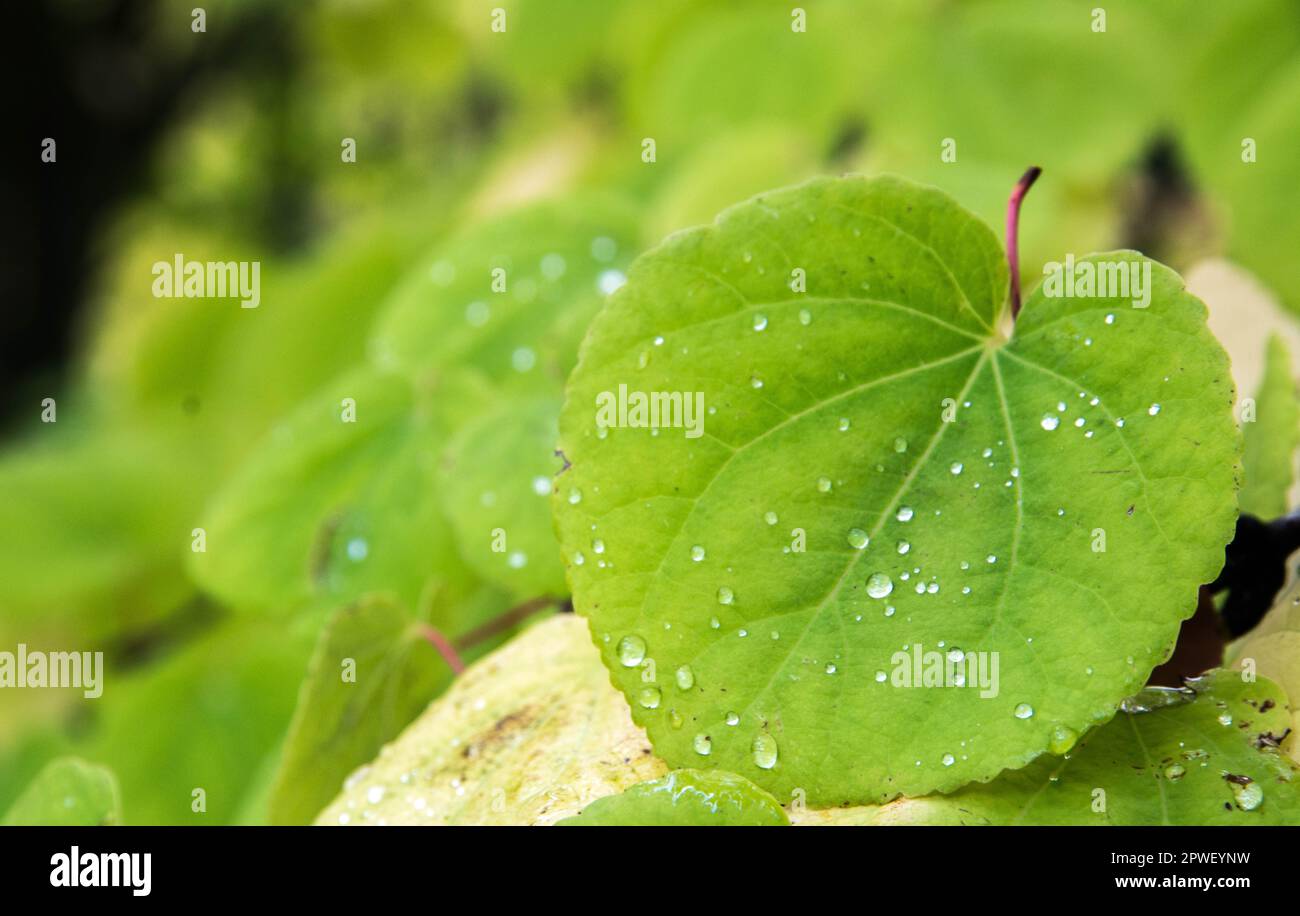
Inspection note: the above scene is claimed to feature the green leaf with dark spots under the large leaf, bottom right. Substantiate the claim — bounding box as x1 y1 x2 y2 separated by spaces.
806 670 1300 826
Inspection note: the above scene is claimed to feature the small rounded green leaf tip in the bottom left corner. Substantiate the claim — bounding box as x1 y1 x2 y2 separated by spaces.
3 757 122 826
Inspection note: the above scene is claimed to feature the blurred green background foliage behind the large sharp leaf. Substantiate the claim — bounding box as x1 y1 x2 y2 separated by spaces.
0 0 1300 824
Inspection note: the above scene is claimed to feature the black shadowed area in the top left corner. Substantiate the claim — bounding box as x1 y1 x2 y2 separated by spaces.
8 0 297 433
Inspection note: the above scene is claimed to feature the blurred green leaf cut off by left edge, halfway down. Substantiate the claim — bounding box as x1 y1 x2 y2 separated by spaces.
0 426 202 639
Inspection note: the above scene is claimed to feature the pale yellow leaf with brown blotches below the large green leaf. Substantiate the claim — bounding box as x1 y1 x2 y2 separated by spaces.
317 615 664 825
